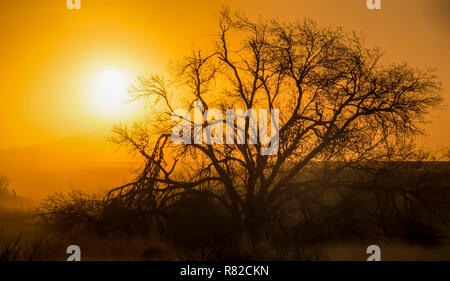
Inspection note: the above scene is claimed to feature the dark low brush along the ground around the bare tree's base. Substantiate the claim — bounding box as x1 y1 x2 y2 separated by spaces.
38 156 450 260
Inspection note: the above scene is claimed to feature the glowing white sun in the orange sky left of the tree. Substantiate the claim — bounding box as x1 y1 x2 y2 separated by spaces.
92 70 130 116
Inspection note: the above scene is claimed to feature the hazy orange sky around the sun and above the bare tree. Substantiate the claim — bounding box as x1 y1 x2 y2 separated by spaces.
0 0 450 148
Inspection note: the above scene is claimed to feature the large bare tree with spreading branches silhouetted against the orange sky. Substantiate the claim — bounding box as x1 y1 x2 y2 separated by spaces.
106 9 441 241
